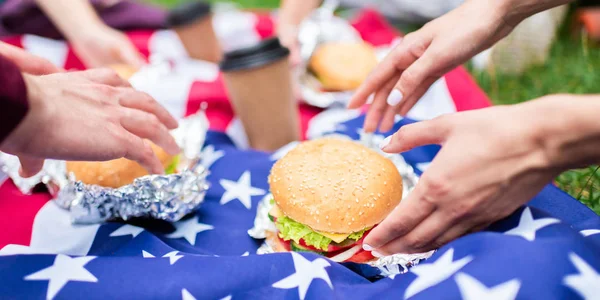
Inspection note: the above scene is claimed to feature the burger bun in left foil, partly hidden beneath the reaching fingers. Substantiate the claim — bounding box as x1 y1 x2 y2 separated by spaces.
67 143 173 188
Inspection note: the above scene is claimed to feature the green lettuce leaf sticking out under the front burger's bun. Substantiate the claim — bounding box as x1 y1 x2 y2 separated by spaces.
275 217 331 251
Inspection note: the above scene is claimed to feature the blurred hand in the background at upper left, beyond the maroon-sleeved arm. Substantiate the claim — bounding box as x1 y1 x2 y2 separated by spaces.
69 24 145 68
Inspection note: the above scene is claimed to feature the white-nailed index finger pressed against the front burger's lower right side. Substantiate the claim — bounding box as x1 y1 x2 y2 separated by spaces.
363 185 436 251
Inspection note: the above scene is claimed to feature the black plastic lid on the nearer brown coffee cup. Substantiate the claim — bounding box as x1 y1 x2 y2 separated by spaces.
220 37 290 72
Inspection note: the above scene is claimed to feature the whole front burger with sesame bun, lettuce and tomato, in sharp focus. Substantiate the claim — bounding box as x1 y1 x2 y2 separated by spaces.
267 138 402 263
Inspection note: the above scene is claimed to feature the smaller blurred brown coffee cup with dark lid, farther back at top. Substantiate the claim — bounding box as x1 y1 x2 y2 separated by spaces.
167 2 222 63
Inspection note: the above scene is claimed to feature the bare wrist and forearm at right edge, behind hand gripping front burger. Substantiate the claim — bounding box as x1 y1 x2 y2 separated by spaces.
523 95 600 170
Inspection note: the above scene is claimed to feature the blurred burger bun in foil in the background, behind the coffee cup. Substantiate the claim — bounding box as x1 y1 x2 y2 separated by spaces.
309 42 378 91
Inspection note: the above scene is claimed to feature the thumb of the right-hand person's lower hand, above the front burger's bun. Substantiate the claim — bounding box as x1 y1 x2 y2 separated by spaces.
380 118 448 153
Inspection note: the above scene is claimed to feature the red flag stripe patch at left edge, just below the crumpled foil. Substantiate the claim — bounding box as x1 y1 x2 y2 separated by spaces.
0 179 51 249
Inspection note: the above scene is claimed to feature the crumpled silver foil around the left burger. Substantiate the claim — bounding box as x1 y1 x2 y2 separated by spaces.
0 111 208 224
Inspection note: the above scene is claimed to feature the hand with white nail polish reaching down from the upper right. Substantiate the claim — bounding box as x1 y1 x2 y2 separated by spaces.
348 1 518 132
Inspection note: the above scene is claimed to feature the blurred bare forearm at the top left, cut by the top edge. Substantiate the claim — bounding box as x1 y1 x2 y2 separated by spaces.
36 0 102 40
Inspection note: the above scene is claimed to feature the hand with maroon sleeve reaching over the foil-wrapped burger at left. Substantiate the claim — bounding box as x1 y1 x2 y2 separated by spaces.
0 69 179 177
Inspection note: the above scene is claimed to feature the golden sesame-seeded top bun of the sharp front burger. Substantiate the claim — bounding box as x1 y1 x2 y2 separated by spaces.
269 138 402 234
